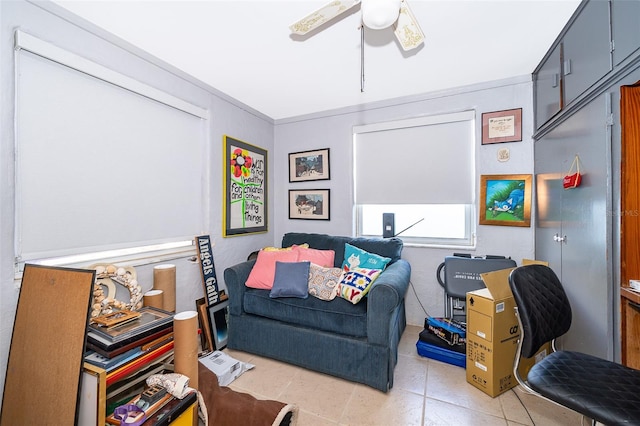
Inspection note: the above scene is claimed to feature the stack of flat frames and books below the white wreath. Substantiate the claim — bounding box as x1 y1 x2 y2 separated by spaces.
84 306 173 386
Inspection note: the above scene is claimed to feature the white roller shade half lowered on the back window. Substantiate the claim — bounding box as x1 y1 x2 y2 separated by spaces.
353 111 475 204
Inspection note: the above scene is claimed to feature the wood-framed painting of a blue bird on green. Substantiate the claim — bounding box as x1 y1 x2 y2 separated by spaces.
480 175 532 227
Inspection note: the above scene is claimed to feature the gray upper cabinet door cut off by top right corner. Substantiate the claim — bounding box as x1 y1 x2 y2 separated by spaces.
611 0 640 66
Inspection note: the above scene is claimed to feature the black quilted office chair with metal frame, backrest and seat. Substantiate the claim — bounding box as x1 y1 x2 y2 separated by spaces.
509 265 640 425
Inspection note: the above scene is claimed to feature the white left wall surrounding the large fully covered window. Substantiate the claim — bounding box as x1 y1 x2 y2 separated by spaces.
0 0 274 406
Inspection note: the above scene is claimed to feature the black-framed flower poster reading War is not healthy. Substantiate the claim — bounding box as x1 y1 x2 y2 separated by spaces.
222 135 268 237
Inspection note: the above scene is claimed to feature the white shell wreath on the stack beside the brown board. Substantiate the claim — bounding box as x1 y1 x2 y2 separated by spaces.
91 264 142 318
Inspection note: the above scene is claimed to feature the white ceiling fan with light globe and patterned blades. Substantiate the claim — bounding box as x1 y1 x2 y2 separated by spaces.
289 0 424 51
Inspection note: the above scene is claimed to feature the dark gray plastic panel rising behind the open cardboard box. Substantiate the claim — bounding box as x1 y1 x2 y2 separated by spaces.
443 256 516 299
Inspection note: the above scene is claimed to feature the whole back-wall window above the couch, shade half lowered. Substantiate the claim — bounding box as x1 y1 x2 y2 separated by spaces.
354 111 475 247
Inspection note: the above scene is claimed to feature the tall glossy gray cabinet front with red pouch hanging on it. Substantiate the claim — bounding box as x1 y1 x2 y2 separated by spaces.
534 94 614 359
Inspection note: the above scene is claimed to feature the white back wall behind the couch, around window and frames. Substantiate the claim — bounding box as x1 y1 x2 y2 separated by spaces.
272 76 534 325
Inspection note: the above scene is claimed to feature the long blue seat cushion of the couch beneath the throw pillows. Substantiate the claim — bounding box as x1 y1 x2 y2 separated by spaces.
243 288 367 340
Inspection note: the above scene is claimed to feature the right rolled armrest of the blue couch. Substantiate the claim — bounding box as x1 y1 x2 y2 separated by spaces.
367 259 411 345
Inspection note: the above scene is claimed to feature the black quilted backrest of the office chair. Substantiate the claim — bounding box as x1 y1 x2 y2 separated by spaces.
509 265 571 358
